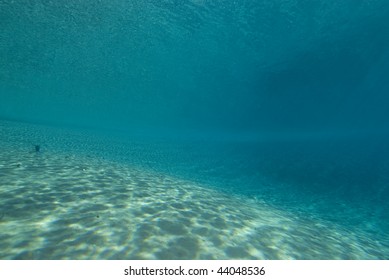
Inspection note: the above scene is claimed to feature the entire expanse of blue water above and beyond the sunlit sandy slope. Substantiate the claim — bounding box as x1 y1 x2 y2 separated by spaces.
0 0 389 259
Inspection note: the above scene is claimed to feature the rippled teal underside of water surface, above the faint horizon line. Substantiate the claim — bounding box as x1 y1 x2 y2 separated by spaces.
0 0 389 133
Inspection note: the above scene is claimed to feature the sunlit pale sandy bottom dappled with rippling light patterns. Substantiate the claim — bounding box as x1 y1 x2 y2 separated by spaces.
0 123 389 259
